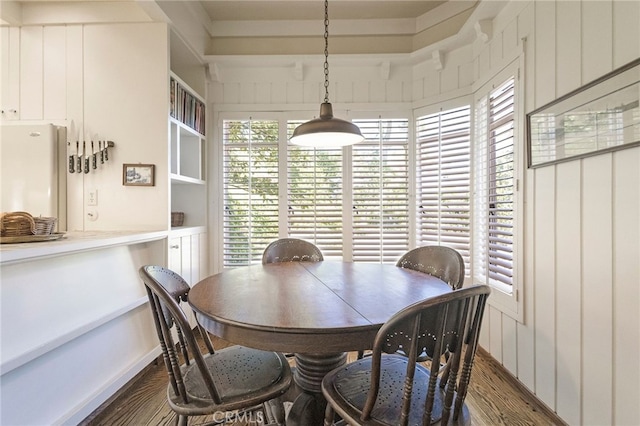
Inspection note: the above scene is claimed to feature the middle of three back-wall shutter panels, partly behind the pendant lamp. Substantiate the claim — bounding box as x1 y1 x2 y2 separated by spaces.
287 121 343 259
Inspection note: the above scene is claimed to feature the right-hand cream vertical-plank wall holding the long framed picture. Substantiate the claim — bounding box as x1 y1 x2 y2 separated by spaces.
475 1 640 425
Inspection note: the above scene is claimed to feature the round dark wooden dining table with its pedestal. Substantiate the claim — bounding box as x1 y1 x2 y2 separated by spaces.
189 261 451 426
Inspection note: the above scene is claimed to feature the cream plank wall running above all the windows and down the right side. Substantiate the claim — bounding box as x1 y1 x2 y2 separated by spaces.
209 1 640 425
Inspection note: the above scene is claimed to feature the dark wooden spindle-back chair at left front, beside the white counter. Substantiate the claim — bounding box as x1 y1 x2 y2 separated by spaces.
139 265 292 425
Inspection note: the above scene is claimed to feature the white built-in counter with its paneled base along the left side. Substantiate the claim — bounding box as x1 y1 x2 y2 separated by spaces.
0 231 168 424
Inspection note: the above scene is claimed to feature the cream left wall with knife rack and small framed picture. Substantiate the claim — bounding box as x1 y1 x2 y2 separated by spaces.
0 23 170 231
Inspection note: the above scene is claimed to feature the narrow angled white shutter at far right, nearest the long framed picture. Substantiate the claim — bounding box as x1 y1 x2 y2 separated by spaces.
474 78 515 286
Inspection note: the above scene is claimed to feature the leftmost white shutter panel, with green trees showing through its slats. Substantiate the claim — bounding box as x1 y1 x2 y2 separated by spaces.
223 120 278 267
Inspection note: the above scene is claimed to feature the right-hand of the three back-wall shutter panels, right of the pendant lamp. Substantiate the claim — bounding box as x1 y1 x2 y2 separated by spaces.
352 119 409 263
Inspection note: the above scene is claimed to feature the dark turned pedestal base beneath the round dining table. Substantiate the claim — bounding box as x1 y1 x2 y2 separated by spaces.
287 352 347 426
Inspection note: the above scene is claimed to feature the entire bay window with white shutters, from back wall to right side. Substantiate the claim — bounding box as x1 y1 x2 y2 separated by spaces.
221 75 521 317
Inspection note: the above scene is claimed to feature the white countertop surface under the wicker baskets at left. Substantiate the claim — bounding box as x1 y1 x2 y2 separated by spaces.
0 231 169 264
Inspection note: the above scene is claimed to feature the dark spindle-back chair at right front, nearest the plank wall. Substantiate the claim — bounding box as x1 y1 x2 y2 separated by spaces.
322 285 491 426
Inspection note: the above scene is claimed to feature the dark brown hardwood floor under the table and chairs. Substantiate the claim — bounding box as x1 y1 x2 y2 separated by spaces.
81 339 565 426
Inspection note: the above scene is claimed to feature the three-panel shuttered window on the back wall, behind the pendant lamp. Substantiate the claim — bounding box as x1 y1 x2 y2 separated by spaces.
222 119 409 267
